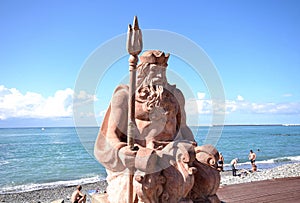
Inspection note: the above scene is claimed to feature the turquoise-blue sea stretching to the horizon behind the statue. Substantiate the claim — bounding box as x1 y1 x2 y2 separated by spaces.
0 125 300 194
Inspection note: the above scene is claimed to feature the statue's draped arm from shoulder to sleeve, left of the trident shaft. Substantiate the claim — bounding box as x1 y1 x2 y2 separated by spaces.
94 86 128 171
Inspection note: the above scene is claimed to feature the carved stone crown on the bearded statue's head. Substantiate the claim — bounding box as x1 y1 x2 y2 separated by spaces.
140 50 170 66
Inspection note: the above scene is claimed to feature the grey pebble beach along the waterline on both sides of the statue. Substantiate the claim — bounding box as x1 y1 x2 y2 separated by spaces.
0 163 300 203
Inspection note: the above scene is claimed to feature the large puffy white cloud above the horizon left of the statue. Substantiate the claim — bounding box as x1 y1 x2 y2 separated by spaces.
0 85 96 120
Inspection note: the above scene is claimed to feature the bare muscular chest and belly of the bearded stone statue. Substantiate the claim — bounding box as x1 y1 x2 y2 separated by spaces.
135 87 179 149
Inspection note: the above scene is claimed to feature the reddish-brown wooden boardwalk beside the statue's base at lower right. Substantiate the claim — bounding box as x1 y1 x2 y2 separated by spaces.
217 177 300 203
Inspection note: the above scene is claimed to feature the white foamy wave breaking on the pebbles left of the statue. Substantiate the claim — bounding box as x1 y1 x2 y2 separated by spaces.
0 176 104 194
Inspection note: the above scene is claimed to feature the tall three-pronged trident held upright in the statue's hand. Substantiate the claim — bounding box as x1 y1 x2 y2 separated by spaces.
126 16 143 203
